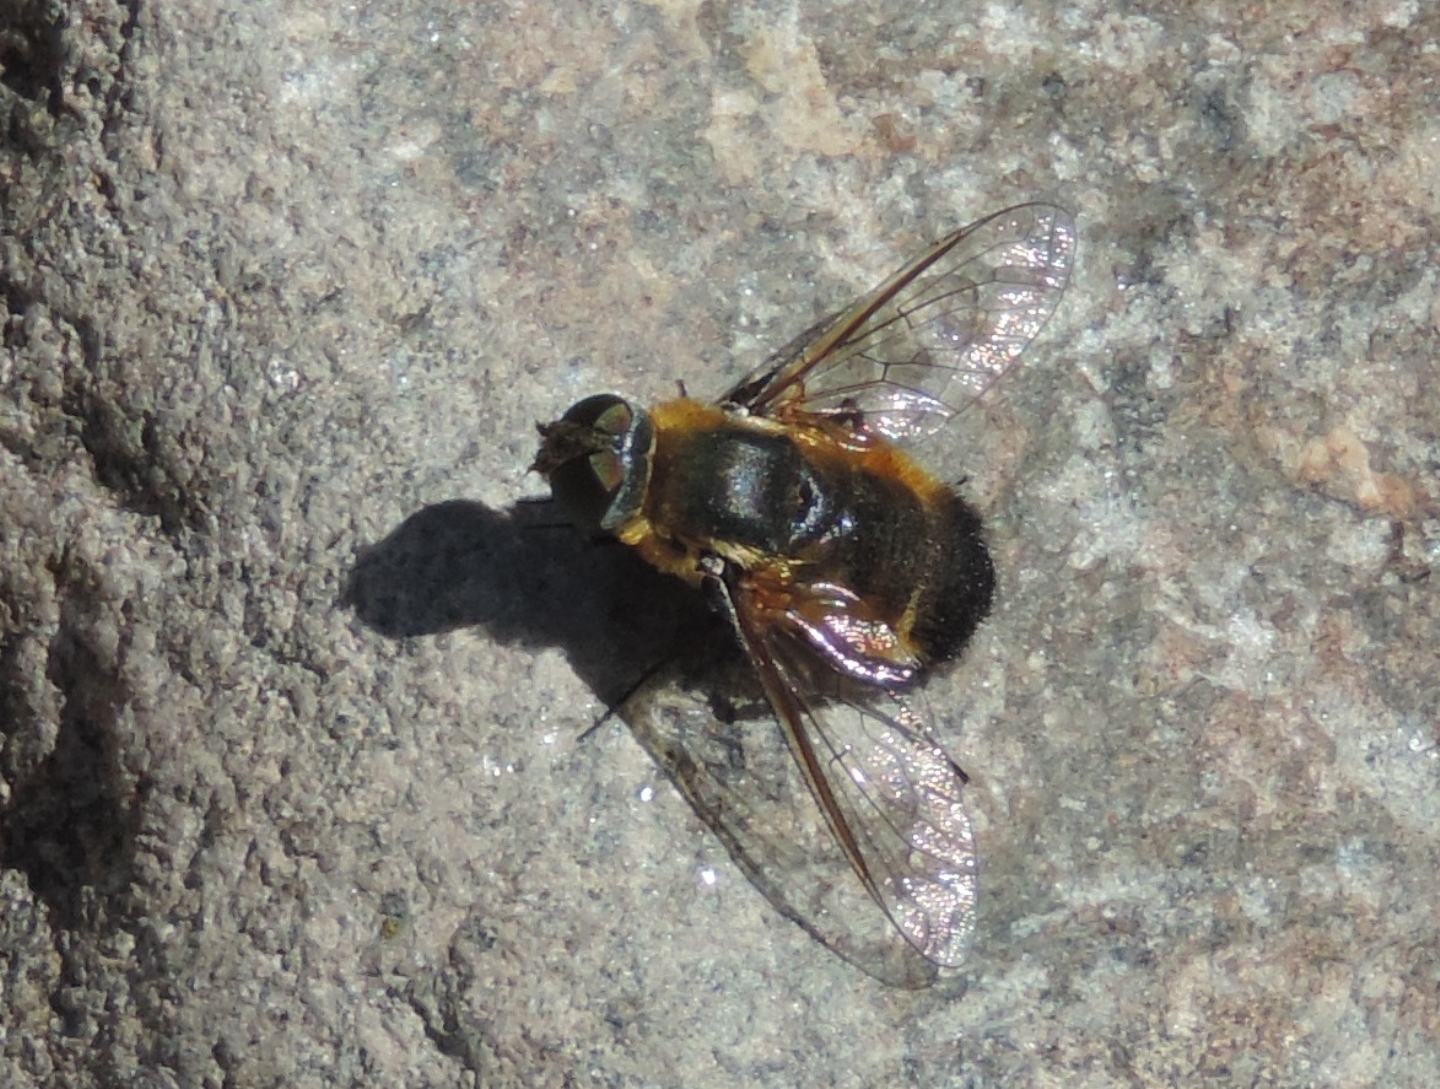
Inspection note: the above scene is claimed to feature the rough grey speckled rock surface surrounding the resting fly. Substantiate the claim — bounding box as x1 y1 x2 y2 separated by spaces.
0 0 1440 1089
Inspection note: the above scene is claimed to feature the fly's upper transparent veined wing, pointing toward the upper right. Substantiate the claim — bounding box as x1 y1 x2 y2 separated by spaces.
720 205 1076 441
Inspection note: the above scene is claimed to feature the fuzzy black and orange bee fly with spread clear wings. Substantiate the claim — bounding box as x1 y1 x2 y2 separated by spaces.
533 205 1076 981
